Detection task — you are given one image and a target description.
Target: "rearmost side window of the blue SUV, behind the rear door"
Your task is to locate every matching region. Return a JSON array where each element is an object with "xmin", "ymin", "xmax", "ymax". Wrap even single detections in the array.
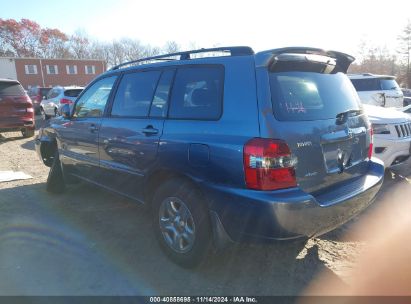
[{"xmin": 169, "ymin": 66, "xmax": 224, "ymax": 120}]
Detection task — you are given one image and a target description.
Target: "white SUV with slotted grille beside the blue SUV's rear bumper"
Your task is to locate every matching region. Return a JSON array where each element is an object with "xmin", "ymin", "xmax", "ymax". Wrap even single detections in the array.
[{"xmin": 364, "ymin": 105, "xmax": 411, "ymax": 167}]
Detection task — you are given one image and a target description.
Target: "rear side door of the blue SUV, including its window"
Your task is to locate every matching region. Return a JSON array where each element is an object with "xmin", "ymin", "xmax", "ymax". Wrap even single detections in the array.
[{"xmin": 99, "ymin": 69, "xmax": 174, "ymax": 199}]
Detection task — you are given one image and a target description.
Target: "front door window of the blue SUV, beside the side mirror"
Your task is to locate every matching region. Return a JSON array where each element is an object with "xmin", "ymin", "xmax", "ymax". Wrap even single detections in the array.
[{"xmin": 74, "ymin": 76, "xmax": 117, "ymax": 118}]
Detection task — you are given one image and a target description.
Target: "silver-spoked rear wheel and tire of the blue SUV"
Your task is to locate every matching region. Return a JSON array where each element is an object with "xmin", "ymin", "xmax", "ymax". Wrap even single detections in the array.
[{"xmin": 152, "ymin": 178, "xmax": 212, "ymax": 268}]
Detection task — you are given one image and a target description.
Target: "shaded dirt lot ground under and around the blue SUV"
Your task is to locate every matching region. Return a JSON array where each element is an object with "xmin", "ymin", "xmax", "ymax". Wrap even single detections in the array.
[{"xmin": 0, "ymin": 116, "xmax": 411, "ymax": 295}]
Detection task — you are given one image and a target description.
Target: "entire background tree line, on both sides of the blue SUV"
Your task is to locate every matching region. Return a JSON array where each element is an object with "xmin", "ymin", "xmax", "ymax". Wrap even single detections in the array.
[{"xmin": 0, "ymin": 18, "xmax": 411, "ymax": 88}]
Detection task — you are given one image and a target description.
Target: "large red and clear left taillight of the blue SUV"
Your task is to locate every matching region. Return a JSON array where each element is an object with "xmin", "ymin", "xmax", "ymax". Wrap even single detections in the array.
[{"xmin": 243, "ymin": 138, "xmax": 297, "ymax": 190}]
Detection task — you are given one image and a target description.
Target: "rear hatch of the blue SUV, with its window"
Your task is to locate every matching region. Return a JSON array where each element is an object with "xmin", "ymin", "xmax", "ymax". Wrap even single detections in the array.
[{"xmin": 268, "ymin": 50, "xmax": 370, "ymax": 194}]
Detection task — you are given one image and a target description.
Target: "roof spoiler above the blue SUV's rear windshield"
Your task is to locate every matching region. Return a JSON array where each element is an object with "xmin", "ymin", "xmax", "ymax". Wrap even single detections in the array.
[{"xmin": 256, "ymin": 47, "xmax": 355, "ymax": 73}]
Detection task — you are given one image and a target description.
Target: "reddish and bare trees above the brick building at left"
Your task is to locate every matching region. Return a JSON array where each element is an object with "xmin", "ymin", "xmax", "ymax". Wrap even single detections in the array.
[{"xmin": 0, "ymin": 18, "xmax": 180, "ymax": 67}]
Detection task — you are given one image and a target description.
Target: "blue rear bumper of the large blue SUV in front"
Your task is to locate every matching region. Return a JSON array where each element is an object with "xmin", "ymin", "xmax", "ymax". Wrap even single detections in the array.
[{"xmin": 205, "ymin": 161, "xmax": 384, "ymax": 242}]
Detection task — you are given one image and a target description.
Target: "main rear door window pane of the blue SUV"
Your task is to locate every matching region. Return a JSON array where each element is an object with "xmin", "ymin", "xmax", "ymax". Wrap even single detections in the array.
[{"xmin": 111, "ymin": 71, "xmax": 161, "ymax": 117}]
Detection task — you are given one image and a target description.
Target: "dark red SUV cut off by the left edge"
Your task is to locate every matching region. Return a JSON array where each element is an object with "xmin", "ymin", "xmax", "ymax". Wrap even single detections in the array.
[{"xmin": 0, "ymin": 79, "xmax": 35, "ymax": 137}]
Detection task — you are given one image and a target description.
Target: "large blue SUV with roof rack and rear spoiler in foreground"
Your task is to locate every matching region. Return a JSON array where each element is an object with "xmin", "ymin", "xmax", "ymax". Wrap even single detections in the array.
[{"xmin": 36, "ymin": 47, "xmax": 384, "ymax": 267}]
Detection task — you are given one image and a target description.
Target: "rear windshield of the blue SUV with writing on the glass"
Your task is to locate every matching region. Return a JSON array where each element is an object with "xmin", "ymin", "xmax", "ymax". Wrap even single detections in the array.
[{"xmin": 270, "ymin": 72, "xmax": 360, "ymax": 120}]
